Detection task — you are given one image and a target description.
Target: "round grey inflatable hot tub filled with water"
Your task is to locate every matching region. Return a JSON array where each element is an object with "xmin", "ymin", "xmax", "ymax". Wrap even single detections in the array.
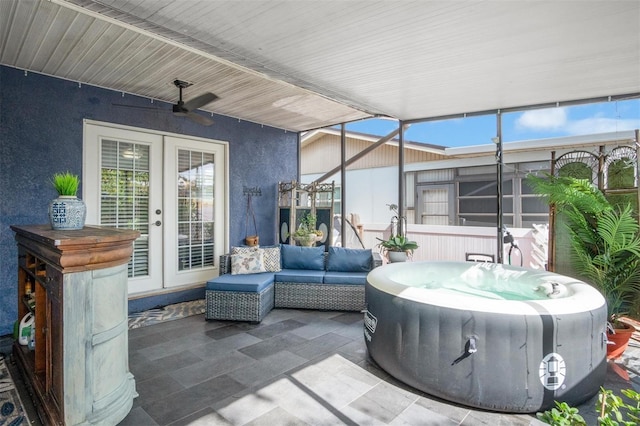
[{"xmin": 364, "ymin": 262, "xmax": 607, "ymax": 413}]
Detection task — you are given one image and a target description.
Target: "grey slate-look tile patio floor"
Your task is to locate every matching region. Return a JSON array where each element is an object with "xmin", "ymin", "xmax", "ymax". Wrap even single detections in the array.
[{"xmin": 116, "ymin": 309, "xmax": 640, "ymax": 426}]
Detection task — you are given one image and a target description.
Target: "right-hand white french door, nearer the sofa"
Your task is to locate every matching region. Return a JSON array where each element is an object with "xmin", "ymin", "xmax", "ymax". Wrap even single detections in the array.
[{"xmin": 164, "ymin": 136, "xmax": 228, "ymax": 287}]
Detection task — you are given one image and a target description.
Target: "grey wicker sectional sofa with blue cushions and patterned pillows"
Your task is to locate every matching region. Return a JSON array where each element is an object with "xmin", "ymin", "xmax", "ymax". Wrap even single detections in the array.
[{"xmin": 205, "ymin": 244, "xmax": 382, "ymax": 322}]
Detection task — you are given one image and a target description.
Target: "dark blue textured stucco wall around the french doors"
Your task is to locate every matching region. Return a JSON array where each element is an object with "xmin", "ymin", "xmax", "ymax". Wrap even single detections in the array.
[{"xmin": 0, "ymin": 66, "xmax": 298, "ymax": 335}]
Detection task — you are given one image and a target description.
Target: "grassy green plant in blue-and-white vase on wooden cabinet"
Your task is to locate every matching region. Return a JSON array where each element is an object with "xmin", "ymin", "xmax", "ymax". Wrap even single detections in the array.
[{"xmin": 49, "ymin": 171, "xmax": 87, "ymax": 230}]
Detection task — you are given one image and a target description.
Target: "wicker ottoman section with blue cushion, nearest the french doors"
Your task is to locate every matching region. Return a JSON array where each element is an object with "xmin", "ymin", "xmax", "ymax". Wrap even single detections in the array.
[{"xmin": 205, "ymin": 272, "xmax": 274, "ymax": 322}]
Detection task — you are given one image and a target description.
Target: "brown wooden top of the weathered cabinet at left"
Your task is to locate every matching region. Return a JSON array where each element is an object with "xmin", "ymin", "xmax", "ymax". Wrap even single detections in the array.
[{"xmin": 11, "ymin": 225, "xmax": 140, "ymax": 273}]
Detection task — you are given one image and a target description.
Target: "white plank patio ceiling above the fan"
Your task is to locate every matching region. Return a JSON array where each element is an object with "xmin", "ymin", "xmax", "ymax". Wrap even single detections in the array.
[{"xmin": 0, "ymin": 0, "xmax": 640, "ymax": 131}]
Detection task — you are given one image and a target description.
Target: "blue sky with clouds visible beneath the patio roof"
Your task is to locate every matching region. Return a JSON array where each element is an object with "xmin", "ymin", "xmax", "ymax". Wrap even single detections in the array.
[{"xmin": 347, "ymin": 99, "xmax": 640, "ymax": 147}]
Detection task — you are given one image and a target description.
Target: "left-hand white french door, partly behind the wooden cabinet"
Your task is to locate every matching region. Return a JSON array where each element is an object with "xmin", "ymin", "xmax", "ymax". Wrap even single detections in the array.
[{"xmin": 82, "ymin": 124, "xmax": 163, "ymax": 294}]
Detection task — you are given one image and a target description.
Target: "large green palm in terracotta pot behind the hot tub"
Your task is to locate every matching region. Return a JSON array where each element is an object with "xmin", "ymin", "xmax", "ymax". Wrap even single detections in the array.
[{"xmin": 529, "ymin": 176, "xmax": 640, "ymax": 358}]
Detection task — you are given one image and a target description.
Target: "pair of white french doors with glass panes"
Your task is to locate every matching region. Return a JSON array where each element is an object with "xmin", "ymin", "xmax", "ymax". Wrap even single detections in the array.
[{"xmin": 83, "ymin": 123, "xmax": 228, "ymax": 294}]
